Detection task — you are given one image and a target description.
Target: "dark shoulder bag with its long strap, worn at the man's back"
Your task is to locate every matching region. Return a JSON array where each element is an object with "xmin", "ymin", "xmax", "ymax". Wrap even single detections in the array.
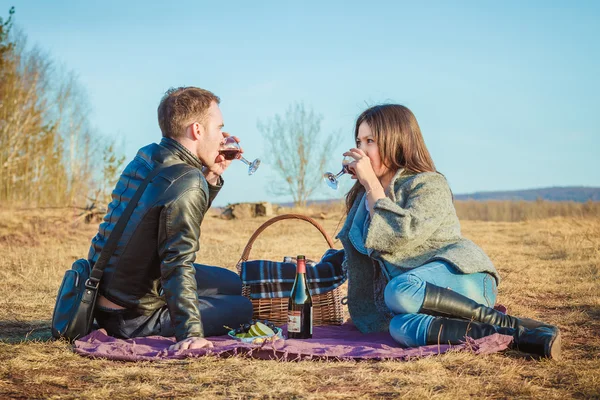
[{"xmin": 52, "ymin": 162, "xmax": 170, "ymax": 341}]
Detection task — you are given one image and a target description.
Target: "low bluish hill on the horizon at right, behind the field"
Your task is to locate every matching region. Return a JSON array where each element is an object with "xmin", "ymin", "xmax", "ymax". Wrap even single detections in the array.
[{"xmin": 454, "ymin": 186, "xmax": 600, "ymax": 203}]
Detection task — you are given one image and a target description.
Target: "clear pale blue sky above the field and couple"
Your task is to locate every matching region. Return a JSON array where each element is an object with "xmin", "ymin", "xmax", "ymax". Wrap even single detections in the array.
[{"xmin": 0, "ymin": 0, "xmax": 600, "ymax": 205}]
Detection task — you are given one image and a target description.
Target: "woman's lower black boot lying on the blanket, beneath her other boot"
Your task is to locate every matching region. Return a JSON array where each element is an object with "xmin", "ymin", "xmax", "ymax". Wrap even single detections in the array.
[{"xmin": 427, "ymin": 317, "xmax": 561, "ymax": 359}]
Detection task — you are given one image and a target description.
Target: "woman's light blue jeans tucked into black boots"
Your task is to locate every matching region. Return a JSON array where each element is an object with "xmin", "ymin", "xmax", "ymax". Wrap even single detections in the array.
[{"xmin": 384, "ymin": 261, "xmax": 498, "ymax": 347}]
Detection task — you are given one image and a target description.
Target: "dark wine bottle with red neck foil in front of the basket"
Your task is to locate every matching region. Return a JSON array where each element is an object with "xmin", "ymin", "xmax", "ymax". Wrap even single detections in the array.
[{"xmin": 288, "ymin": 256, "xmax": 312, "ymax": 339}]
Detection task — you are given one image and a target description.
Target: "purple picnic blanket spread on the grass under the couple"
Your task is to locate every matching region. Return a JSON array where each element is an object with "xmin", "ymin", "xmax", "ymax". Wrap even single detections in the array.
[{"xmin": 74, "ymin": 323, "xmax": 512, "ymax": 361}]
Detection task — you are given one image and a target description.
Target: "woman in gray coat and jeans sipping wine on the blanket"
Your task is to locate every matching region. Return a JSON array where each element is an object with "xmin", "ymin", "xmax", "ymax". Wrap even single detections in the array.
[{"xmin": 338, "ymin": 104, "xmax": 560, "ymax": 358}]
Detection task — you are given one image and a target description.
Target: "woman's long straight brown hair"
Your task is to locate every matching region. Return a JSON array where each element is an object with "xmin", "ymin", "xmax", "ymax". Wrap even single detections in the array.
[{"xmin": 346, "ymin": 104, "xmax": 437, "ymax": 213}]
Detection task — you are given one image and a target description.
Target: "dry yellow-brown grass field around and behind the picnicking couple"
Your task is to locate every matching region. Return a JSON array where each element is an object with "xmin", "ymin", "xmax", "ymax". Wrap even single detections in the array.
[{"xmin": 0, "ymin": 205, "xmax": 600, "ymax": 399}]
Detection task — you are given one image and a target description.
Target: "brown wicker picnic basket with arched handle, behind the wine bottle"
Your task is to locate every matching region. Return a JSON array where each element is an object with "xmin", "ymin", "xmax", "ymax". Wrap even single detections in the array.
[{"xmin": 238, "ymin": 214, "xmax": 344, "ymax": 325}]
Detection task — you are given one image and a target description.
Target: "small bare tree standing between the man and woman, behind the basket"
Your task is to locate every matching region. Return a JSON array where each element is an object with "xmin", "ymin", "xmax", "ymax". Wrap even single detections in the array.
[{"xmin": 257, "ymin": 103, "xmax": 340, "ymax": 206}]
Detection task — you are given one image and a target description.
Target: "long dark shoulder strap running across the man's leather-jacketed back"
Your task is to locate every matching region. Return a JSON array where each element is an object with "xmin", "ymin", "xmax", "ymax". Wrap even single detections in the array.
[{"xmin": 85, "ymin": 163, "xmax": 174, "ymax": 289}]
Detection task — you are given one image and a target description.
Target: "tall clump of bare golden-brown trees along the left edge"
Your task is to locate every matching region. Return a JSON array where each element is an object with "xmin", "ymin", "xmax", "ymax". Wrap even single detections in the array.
[{"xmin": 0, "ymin": 8, "xmax": 123, "ymax": 206}]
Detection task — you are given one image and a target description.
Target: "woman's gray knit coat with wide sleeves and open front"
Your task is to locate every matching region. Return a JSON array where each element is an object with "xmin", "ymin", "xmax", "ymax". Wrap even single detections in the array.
[{"xmin": 337, "ymin": 170, "xmax": 500, "ymax": 333}]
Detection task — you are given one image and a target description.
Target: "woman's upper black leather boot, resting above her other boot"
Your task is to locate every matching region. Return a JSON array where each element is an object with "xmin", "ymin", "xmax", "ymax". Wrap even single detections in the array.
[{"xmin": 419, "ymin": 283, "xmax": 558, "ymax": 334}]
